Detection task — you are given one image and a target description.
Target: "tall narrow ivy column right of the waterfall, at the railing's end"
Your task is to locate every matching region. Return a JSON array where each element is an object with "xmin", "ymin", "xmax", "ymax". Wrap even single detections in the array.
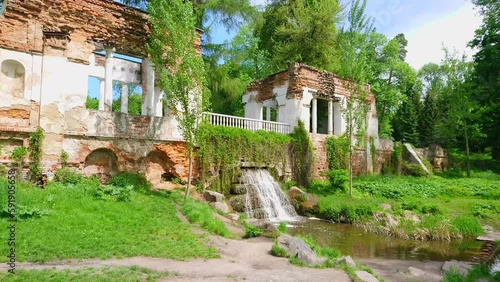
[{"xmin": 290, "ymin": 121, "xmax": 314, "ymax": 187}]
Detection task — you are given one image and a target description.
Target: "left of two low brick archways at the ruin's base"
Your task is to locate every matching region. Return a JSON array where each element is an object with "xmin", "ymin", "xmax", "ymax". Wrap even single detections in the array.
[{"xmin": 83, "ymin": 148, "xmax": 117, "ymax": 183}]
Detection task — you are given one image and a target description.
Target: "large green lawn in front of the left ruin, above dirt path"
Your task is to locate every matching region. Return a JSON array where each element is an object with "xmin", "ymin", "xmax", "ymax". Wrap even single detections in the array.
[{"xmin": 0, "ymin": 179, "xmax": 218, "ymax": 262}]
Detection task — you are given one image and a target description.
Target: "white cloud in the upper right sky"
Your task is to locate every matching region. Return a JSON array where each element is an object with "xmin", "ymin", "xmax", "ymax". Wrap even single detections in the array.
[{"xmin": 405, "ymin": 2, "xmax": 481, "ymax": 69}]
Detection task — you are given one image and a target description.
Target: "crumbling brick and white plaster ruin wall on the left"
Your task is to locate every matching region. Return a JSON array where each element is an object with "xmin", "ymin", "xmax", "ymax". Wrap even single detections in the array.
[{"xmin": 0, "ymin": 0, "xmax": 201, "ymax": 182}]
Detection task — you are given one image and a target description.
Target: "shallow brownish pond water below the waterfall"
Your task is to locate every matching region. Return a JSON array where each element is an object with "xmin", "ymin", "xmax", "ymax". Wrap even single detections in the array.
[{"xmin": 287, "ymin": 219, "xmax": 482, "ymax": 261}]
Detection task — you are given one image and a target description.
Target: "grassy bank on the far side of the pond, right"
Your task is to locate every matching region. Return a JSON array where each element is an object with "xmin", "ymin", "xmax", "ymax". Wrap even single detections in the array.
[{"xmin": 319, "ymin": 172, "xmax": 500, "ymax": 240}]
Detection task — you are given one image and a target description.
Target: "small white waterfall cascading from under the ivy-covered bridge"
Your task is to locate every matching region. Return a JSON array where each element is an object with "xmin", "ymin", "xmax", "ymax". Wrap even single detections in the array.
[{"xmin": 241, "ymin": 169, "xmax": 297, "ymax": 221}]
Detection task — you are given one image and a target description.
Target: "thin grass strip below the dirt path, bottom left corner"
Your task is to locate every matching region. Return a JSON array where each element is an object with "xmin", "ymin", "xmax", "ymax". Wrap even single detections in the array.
[{"xmin": 0, "ymin": 267, "xmax": 171, "ymax": 282}]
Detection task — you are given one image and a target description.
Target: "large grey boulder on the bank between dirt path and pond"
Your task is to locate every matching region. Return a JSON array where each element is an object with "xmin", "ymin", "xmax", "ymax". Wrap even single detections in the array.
[{"xmin": 277, "ymin": 234, "xmax": 326, "ymax": 266}]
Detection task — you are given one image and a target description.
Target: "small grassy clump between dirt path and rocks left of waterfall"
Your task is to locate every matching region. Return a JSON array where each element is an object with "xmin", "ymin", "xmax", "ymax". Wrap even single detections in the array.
[{"xmin": 181, "ymin": 200, "xmax": 234, "ymax": 238}]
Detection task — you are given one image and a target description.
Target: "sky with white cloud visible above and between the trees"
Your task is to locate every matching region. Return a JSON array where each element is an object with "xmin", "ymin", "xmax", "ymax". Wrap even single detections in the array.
[{"xmin": 211, "ymin": 0, "xmax": 481, "ymax": 69}]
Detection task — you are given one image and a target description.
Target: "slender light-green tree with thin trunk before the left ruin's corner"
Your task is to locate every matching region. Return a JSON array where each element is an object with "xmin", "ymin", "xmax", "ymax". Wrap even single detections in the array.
[{"xmin": 146, "ymin": 0, "xmax": 208, "ymax": 199}]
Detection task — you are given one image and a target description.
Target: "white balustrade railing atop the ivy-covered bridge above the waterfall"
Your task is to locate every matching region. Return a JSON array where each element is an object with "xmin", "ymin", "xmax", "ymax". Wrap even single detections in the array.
[{"xmin": 203, "ymin": 112, "xmax": 290, "ymax": 134}]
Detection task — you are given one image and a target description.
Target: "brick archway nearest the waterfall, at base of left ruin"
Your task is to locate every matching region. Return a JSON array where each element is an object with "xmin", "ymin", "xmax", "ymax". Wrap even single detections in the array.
[{"xmin": 140, "ymin": 150, "xmax": 176, "ymax": 186}]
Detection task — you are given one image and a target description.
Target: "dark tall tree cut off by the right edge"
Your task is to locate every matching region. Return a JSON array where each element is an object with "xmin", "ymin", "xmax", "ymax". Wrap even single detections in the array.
[{"xmin": 470, "ymin": 0, "xmax": 500, "ymax": 160}]
